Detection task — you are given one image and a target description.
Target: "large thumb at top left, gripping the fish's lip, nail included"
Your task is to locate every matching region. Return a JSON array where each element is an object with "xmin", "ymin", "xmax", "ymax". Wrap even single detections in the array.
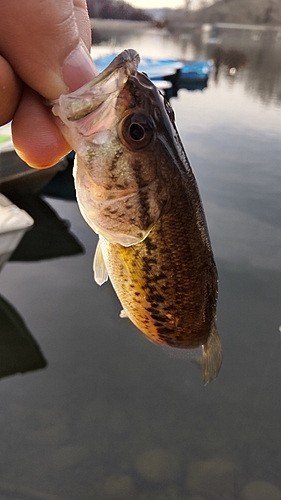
[{"xmin": 0, "ymin": 0, "xmax": 96, "ymax": 99}]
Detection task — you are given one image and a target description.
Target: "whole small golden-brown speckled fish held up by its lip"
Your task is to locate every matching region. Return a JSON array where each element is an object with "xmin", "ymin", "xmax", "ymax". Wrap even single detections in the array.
[{"xmin": 52, "ymin": 49, "xmax": 222, "ymax": 384}]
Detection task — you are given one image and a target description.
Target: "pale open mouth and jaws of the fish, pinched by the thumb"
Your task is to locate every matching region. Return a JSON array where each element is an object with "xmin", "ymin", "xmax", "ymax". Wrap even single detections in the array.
[{"xmin": 52, "ymin": 49, "xmax": 158, "ymax": 144}]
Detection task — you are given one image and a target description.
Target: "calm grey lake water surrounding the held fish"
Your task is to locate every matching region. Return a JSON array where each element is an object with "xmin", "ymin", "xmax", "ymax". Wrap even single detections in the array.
[{"xmin": 0, "ymin": 25, "xmax": 281, "ymax": 500}]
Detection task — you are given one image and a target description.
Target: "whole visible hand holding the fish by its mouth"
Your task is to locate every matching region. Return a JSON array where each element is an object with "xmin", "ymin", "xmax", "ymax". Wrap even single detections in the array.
[{"xmin": 0, "ymin": 0, "xmax": 97, "ymax": 168}]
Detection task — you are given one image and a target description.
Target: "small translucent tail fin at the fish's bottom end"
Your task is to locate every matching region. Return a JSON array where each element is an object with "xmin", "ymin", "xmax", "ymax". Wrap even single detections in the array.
[{"xmin": 202, "ymin": 321, "xmax": 222, "ymax": 385}]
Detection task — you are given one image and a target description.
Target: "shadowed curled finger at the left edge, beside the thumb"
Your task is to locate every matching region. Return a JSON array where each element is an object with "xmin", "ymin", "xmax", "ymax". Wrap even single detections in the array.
[{"xmin": 0, "ymin": 56, "xmax": 22, "ymax": 126}]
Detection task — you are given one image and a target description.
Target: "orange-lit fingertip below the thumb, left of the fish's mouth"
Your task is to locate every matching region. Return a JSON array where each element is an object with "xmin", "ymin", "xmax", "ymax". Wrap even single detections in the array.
[{"xmin": 12, "ymin": 87, "xmax": 70, "ymax": 168}]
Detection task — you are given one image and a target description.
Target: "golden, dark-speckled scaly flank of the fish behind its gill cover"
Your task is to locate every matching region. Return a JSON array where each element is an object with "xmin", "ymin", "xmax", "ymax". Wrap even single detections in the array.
[{"xmin": 103, "ymin": 188, "xmax": 213, "ymax": 347}]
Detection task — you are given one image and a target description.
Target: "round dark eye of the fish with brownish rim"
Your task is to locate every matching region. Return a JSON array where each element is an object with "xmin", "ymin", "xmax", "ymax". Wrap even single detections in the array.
[{"xmin": 118, "ymin": 112, "xmax": 155, "ymax": 150}]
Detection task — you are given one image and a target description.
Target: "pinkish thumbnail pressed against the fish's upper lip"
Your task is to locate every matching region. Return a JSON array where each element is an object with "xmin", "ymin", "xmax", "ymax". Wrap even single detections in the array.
[{"xmin": 62, "ymin": 42, "xmax": 98, "ymax": 92}]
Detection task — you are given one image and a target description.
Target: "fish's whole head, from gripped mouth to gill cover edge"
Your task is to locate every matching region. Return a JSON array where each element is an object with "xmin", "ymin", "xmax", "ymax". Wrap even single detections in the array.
[{"xmin": 53, "ymin": 49, "xmax": 179, "ymax": 246}]
